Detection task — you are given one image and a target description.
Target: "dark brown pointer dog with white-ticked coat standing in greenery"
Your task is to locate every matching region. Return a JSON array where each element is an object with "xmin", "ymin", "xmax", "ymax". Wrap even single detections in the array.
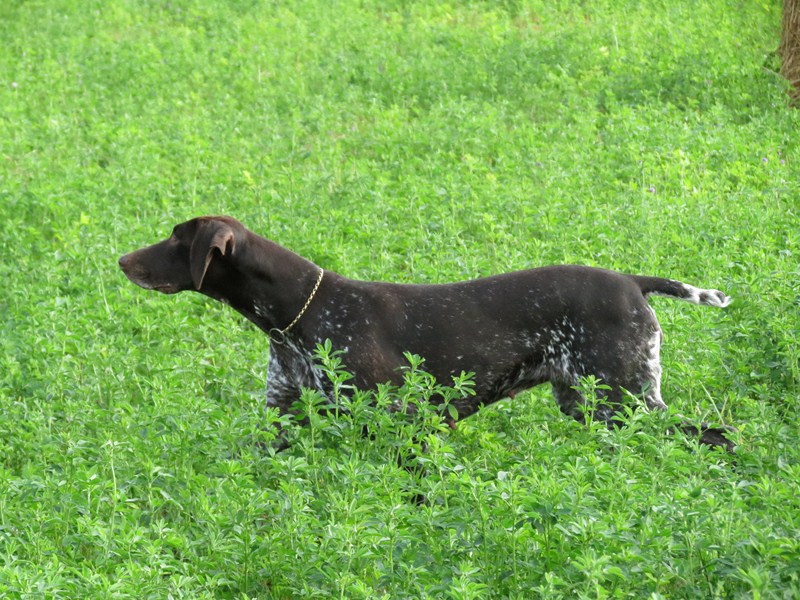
[{"xmin": 119, "ymin": 216, "xmax": 733, "ymax": 451}]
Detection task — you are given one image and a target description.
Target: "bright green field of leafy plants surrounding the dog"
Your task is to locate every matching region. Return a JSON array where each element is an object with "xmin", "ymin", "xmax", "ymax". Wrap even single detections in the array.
[{"xmin": 0, "ymin": 0, "xmax": 800, "ymax": 599}]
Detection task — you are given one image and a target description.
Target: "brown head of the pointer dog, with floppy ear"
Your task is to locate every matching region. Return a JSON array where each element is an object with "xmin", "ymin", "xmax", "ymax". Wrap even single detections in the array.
[{"xmin": 119, "ymin": 217, "xmax": 243, "ymax": 294}]
